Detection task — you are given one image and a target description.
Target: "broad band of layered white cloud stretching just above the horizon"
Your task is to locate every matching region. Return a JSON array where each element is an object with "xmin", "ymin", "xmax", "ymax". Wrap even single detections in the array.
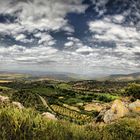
[{"xmin": 0, "ymin": 41, "xmax": 140, "ymax": 74}]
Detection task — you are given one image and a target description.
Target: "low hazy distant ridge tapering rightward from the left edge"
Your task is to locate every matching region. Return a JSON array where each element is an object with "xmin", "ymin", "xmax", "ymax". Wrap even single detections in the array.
[{"xmin": 0, "ymin": 71, "xmax": 88, "ymax": 81}]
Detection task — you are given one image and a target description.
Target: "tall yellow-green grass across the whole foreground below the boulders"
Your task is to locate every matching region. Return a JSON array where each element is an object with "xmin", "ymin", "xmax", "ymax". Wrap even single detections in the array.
[{"xmin": 0, "ymin": 106, "xmax": 140, "ymax": 140}]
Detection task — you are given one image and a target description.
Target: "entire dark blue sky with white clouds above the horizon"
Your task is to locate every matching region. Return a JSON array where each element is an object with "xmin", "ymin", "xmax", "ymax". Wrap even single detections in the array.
[{"xmin": 0, "ymin": 0, "xmax": 140, "ymax": 75}]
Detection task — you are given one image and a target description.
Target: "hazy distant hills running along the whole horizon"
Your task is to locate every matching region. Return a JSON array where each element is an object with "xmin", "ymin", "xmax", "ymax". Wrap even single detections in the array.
[{"xmin": 0, "ymin": 71, "xmax": 140, "ymax": 81}]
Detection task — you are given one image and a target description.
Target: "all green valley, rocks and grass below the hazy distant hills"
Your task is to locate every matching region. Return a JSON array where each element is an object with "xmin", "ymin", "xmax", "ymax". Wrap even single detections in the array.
[{"xmin": 0, "ymin": 80, "xmax": 140, "ymax": 140}]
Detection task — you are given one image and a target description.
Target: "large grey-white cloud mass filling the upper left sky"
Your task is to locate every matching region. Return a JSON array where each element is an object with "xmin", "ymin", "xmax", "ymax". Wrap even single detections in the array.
[{"xmin": 0, "ymin": 0, "xmax": 87, "ymax": 45}]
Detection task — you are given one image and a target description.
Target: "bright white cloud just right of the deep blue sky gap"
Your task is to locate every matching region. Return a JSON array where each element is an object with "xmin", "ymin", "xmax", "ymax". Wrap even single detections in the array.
[{"xmin": 89, "ymin": 20, "xmax": 140, "ymax": 43}]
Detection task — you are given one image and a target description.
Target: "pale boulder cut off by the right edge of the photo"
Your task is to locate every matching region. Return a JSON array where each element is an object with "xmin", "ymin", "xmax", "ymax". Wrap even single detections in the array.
[{"xmin": 128, "ymin": 100, "xmax": 140, "ymax": 113}]
